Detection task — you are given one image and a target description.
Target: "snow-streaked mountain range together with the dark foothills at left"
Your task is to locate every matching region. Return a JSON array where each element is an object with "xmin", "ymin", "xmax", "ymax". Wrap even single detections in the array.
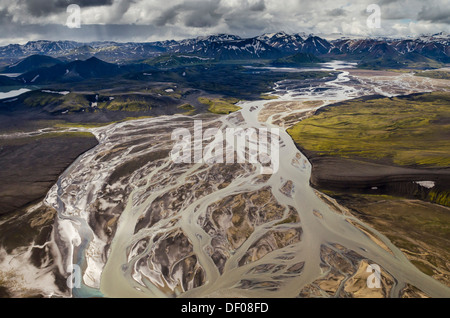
[{"xmin": 0, "ymin": 32, "xmax": 450, "ymax": 86}]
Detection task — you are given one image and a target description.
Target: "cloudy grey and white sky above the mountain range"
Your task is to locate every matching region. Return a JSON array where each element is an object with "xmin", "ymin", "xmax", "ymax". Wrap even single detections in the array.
[{"xmin": 0, "ymin": 0, "xmax": 450, "ymax": 45}]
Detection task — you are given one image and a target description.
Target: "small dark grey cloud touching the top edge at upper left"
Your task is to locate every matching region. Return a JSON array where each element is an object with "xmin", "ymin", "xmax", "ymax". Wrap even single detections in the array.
[{"xmin": 21, "ymin": 0, "xmax": 113, "ymax": 17}]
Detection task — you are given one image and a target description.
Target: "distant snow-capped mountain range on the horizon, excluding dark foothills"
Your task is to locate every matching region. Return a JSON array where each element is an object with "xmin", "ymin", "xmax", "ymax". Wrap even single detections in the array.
[{"xmin": 0, "ymin": 32, "xmax": 450, "ymax": 65}]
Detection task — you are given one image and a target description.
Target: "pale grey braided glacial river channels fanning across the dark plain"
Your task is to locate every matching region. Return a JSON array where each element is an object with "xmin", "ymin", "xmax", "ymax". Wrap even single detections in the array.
[{"xmin": 46, "ymin": 62, "xmax": 450, "ymax": 298}]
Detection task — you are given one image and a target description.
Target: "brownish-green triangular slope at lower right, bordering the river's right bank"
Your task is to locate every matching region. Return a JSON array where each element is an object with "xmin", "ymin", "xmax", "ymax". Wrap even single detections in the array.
[{"xmin": 328, "ymin": 192, "xmax": 450, "ymax": 285}]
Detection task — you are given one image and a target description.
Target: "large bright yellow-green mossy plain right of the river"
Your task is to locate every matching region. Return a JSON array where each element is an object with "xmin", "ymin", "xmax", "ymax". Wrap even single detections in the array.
[{"xmin": 288, "ymin": 92, "xmax": 450, "ymax": 167}]
